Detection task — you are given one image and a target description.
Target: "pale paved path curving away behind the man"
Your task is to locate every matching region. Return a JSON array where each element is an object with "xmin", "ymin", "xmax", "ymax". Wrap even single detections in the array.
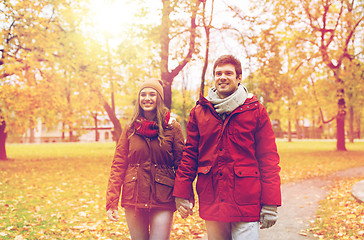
[{"xmin": 202, "ymin": 166, "xmax": 364, "ymax": 240}]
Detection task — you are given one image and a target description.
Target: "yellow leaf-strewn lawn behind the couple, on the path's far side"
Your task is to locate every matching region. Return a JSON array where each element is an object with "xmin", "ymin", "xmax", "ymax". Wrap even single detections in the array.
[{"xmin": 0, "ymin": 142, "xmax": 364, "ymax": 239}]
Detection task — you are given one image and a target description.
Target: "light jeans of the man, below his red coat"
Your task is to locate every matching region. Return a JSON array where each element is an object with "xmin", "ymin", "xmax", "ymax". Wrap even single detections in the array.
[{"xmin": 205, "ymin": 221, "xmax": 259, "ymax": 240}]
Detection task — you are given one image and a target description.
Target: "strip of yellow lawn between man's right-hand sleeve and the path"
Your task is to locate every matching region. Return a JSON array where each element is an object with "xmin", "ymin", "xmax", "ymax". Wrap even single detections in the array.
[{"xmin": 277, "ymin": 141, "xmax": 364, "ymax": 183}]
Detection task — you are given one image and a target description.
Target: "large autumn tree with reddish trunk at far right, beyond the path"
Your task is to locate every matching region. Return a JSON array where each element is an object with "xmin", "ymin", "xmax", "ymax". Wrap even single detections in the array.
[{"xmin": 229, "ymin": 0, "xmax": 363, "ymax": 150}]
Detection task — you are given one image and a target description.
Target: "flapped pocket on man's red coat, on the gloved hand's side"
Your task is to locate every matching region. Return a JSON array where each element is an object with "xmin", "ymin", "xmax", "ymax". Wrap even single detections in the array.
[{"xmin": 234, "ymin": 166, "xmax": 261, "ymax": 205}]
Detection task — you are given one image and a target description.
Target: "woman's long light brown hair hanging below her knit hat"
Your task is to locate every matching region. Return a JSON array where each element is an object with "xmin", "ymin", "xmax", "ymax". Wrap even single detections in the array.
[{"xmin": 129, "ymin": 93, "xmax": 168, "ymax": 145}]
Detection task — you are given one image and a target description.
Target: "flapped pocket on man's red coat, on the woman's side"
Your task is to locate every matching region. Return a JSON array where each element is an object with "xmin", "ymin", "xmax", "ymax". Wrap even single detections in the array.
[{"xmin": 196, "ymin": 166, "xmax": 215, "ymax": 204}]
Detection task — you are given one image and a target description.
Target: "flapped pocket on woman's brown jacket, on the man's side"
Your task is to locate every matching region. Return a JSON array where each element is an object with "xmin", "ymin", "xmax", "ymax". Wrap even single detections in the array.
[{"xmin": 154, "ymin": 172, "xmax": 174, "ymax": 203}]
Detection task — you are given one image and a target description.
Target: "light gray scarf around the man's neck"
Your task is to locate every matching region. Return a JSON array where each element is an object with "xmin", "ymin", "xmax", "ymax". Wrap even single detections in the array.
[{"xmin": 206, "ymin": 84, "xmax": 252, "ymax": 116}]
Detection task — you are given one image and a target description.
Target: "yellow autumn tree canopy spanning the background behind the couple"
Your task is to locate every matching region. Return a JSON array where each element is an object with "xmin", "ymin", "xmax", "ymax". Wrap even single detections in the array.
[{"xmin": 0, "ymin": 0, "xmax": 364, "ymax": 156}]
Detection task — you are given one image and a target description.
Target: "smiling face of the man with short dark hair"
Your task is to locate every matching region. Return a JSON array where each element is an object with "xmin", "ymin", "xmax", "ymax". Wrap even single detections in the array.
[{"xmin": 214, "ymin": 63, "xmax": 241, "ymax": 98}]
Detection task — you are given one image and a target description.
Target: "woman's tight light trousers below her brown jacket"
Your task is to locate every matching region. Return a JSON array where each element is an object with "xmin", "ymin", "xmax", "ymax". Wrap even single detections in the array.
[{"xmin": 125, "ymin": 207, "xmax": 173, "ymax": 240}]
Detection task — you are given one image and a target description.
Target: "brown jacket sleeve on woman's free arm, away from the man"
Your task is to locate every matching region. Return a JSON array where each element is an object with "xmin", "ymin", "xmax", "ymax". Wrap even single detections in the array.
[{"xmin": 106, "ymin": 127, "xmax": 129, "ymax": 211}]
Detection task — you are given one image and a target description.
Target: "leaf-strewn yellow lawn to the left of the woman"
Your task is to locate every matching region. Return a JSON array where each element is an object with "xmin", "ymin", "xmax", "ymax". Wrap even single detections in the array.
[{"xmin": 0, "ymin": 143, "xmax": 127, "ymax": 239}]
